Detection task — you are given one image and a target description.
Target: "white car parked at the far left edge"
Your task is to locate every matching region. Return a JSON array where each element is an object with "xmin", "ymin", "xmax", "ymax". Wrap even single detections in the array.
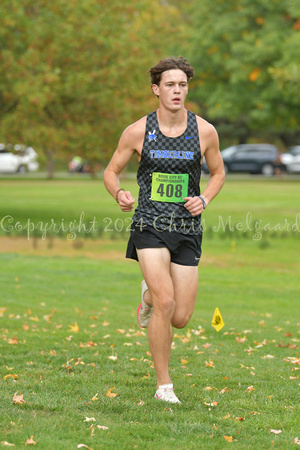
[{"xmin": 0, "ymin": 144, "xmax": 39, "ymax": 173}]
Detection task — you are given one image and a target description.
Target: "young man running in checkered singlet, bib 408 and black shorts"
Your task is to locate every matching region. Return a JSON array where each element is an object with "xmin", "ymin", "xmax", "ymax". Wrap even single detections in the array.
[{"xmin": 104, "ymin": 57, "xmax": 225, "ymax": 403}]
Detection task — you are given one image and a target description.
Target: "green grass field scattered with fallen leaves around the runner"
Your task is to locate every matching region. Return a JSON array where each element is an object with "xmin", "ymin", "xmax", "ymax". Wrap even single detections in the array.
[{"xmin": 0, "ymin": 177, "xmax": 300, "ymax": 450}]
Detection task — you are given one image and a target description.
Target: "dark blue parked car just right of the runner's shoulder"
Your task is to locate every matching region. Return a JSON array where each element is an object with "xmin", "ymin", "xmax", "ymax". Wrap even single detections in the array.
[{"xmin": 221, "ymin": 144, "xmax": 285, "ymax": 176}]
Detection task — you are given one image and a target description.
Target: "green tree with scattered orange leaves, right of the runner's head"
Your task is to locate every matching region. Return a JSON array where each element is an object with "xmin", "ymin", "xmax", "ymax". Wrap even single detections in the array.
[{"xmin": 182, "ymin": 0, "xmax": 300, "ymax": 145}]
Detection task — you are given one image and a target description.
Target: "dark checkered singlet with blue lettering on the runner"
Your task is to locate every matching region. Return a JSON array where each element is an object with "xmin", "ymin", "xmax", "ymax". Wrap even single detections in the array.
[{"xmin": 133, "ymin": 111, "xmax": 201, "ymax": 235}]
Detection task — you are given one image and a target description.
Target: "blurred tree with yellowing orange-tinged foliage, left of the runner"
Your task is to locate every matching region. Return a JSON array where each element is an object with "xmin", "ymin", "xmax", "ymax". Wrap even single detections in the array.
[{"xmin": 0, "ymin": 0, "xmax": 180, "ymax": 176}]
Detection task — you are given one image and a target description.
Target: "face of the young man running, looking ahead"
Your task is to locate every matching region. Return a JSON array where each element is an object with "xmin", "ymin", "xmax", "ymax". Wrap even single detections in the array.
[{"xmin": 152, "ymin": 69, "xmax": 188, "ymax": 110}]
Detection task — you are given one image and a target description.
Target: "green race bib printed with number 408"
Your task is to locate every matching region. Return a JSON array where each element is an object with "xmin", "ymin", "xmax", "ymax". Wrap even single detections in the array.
[{"xmin": 151, "ymin": 172, "xmax": 189, "ymax": 203}]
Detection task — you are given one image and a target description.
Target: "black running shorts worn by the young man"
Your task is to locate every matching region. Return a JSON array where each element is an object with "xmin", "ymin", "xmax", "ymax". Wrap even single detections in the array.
[{"xmin": 126, "ymin": 223, "xmax": 202, "ymax": 266}]
